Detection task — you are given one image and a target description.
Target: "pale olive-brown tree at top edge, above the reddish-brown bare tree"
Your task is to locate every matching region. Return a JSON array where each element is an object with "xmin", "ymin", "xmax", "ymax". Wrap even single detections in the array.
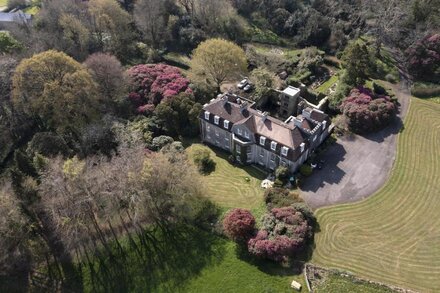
[{"xmin": 88, "ymin": 0, "xmax": 133, "ymax": 59}]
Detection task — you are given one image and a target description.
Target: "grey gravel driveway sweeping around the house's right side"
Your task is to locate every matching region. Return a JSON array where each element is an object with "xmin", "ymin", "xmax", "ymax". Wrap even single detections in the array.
[{"xmin": 301, "ymin": 81, "xmax": 410, "ymax": 209}]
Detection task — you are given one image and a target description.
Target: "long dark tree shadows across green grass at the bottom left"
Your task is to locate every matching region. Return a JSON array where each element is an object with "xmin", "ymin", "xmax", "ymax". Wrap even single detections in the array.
[{"xmin": 83, "ymin": 226, "xmax": 226, "ymax": 292}]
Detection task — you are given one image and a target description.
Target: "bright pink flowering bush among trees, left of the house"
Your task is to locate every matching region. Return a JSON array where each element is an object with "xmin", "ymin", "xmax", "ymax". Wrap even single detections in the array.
[{"xmin": 127, "ymin": 64, "xmax": 192, "ymax": 113}]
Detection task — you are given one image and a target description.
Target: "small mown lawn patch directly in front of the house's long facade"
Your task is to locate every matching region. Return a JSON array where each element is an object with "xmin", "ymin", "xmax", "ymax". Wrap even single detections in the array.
[{"xmin": 188, "ymin": 143, "xmax": 266, "ymax": 209}]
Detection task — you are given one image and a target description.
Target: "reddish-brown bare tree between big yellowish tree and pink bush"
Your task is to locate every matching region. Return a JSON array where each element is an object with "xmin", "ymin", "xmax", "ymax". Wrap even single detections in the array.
[{"xmin": 84, "ymin": 53, "xmax": 126, "ymax": 102}]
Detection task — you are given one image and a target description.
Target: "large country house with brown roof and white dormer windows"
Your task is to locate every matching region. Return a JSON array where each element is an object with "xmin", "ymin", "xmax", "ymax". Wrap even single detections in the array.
[{"xmin": 199, "ymin": 94, "xmax": 331, "ymax": 172}]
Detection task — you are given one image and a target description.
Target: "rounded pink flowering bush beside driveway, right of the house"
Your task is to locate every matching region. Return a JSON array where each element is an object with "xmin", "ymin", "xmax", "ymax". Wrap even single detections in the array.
[{"xmin": 341, "ymin": 87, "xmax": 397, "ymax": 133}]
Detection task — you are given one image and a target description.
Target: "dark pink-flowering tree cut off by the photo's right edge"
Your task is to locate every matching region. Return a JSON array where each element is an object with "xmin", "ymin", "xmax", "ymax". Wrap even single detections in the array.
[{"xmin": 406, "ymin": 34, "xmax": 440, "ymax": 82}]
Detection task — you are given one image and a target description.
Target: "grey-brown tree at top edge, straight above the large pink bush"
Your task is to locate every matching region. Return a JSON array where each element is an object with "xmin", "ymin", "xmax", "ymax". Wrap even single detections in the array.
[{"xmin": 134, "ymin": 0, "xmax": 169, "ymax": 48}]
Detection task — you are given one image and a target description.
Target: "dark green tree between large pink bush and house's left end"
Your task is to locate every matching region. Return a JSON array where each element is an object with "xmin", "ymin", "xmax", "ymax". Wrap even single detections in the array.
[{"xmin": 154, "ymin": 93, "xmax": 202, "ymax": 136}]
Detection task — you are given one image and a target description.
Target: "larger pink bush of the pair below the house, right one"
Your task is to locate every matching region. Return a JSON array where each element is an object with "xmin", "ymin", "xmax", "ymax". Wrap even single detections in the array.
[{"xmin": 248, "ymin": 207, "xmax": 313, "ymax": 262}]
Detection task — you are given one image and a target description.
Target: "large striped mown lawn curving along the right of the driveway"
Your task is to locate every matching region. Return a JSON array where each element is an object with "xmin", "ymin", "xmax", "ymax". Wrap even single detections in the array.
[{"xmin": 312, "ymin": 98, "xmax": 440, "ymax": 292}]
